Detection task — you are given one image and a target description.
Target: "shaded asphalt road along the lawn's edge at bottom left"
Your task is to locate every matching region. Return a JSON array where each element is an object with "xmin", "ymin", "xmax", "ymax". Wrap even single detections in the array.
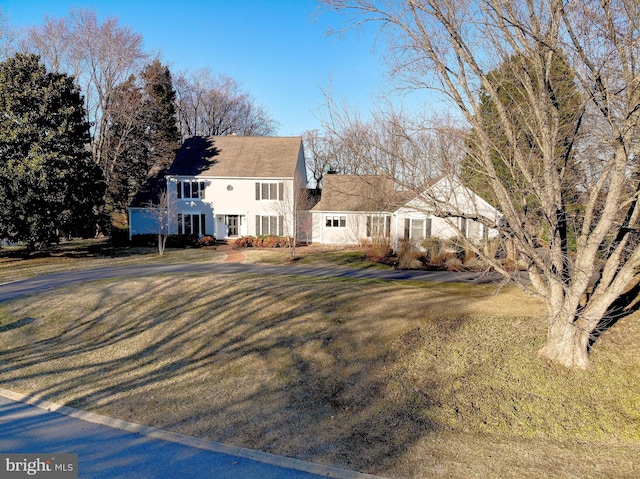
[{"xmin": 0, "ymin": 391, "xmax": 374, "ymax": 479}]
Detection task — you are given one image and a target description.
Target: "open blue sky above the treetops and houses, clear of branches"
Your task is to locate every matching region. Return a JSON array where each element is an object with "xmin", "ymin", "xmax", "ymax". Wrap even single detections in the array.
[{"xmin": 0, "ymin": 0, "xmax": 386, "ymax": 136}]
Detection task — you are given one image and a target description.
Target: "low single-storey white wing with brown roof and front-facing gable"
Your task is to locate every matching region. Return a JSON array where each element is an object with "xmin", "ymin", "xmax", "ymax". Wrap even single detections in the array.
[{"xmin": 311, "ymin": 175, "xmax": 500, "ymax": 248}]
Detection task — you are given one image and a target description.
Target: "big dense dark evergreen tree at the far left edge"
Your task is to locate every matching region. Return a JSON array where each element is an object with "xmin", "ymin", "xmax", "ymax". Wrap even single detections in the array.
[{"xmin": 0, "ymin": 54, "xmax": 105, "ymax": 248}]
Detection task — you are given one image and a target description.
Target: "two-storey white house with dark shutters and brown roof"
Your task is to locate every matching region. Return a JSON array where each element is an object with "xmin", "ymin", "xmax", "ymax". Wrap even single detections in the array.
[{"xmin": 129, "ymin": 136, "xmax": 307, "ymax": 239}]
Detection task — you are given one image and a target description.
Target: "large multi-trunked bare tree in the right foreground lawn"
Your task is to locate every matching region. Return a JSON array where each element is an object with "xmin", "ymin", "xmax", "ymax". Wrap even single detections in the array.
[{"xmin": 325, "ymin": 0, "xmax": 640, "ymax": 368}]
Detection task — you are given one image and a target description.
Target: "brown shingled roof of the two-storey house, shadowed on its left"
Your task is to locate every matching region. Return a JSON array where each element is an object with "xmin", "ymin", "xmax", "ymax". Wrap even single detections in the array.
[{"xmin": 167, "ymin": 136, "xmax": 302, "ymax": 178}]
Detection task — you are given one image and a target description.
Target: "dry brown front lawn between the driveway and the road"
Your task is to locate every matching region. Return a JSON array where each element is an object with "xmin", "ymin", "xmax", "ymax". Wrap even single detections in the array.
[{"xmin": 0, "ymin": 276, "xmax": 640, "ymax": 478}]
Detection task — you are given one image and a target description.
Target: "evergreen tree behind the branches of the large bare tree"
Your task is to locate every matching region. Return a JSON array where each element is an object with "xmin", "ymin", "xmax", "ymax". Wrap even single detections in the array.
[{"xmin": 462, "ymin": 55, "xmax": 584, "ymax": 248}]
